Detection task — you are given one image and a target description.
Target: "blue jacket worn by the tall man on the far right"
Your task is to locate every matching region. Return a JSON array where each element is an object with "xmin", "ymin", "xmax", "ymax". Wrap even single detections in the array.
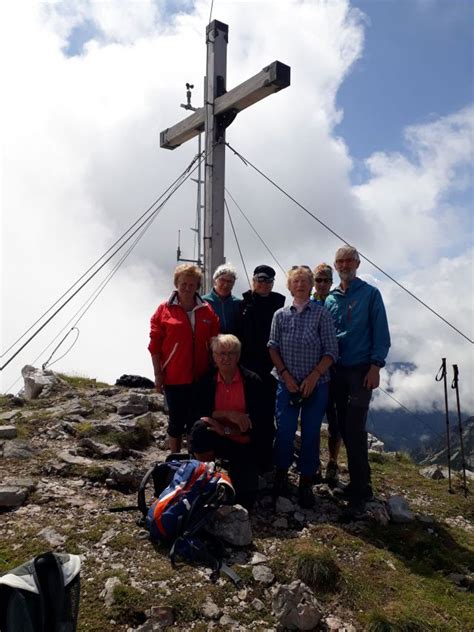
[{"xmin": 324, "ymin": 277, "xmax": 390, "ymax": 366}]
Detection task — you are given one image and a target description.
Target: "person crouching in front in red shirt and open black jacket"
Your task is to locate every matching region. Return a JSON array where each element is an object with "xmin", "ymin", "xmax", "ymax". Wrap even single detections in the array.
[{"xmin": 191, "ymin": 334, "xmax": 262, "ymax": 508}]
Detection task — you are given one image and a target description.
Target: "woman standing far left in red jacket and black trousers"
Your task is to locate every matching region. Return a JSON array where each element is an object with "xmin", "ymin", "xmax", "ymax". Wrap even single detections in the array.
[{"xmin": 148, "ymin": 263, "xmax": 219, "ymax": 452}]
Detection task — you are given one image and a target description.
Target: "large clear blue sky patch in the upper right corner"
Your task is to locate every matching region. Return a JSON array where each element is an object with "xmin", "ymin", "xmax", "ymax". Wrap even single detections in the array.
[{"xmin": 336, "ymin": 0, "xmax": 474, "ymax": 160}]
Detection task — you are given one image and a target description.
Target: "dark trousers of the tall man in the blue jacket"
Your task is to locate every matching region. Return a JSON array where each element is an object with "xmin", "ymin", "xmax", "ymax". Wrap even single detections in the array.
[{"xmin": 333, "ymin": 364, "xmax": 372, "ymax": 500}]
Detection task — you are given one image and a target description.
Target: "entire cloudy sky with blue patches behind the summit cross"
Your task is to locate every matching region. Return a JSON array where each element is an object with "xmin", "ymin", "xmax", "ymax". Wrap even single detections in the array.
[{"xmin": 0, "ymin": 0, "xmax": 474, "ymax": 422}]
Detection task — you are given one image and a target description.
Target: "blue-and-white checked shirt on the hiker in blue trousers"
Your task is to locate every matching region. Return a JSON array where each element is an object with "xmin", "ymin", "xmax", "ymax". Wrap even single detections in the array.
[{"xmin": 268, "ymin": 301, "xmax": 338, "ymax": 384}]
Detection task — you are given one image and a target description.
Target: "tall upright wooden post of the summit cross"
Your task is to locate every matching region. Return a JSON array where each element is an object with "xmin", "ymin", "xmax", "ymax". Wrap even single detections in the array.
[{"xmin": 204, "ymin": 20, "xmax": 229, "ymax": 292}]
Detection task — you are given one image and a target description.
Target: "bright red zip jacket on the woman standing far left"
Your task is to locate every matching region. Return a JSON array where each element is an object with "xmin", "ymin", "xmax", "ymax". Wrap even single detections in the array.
[{"xmin": 148, "ymin": 292, "xmax": 219, "ymax": 384}]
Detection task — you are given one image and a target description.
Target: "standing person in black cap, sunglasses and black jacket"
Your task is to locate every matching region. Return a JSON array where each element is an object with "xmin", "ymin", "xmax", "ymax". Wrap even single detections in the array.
[{"xmin": 239, "ymin": 265, "xmax": 285, "ymax": 472}]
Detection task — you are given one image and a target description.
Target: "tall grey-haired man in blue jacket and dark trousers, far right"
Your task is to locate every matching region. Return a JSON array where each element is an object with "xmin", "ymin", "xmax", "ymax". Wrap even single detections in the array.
[{"xmin": 324, "ymin": 246, "xmax": 390, "ymax": 514}]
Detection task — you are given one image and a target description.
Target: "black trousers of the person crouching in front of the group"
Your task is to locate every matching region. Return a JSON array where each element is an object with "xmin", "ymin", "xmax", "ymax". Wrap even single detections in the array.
[{"xmin": 191, "ymin": 420, "xmax": 258, "ymax": 507}]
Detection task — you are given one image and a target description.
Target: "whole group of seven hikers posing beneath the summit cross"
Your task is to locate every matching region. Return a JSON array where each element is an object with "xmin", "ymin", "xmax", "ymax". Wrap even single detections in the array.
[{"xmin": 148, "ymin": 246, "xmax": 390, "ymax": 515}]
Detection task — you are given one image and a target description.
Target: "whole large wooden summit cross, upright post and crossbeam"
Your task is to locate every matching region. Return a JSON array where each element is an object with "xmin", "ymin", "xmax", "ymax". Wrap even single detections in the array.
[{"xmin": 160, "ymin": 20, "xmax": 290, "ymax": 292}]
